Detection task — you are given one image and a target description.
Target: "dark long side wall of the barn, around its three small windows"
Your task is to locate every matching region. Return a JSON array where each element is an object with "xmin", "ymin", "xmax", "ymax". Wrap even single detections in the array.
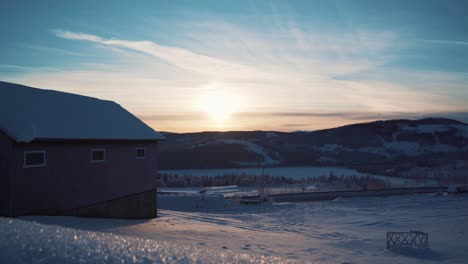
[{"xmin": 9, "ymin": 141, "xmax": 157, "ymax": 215}]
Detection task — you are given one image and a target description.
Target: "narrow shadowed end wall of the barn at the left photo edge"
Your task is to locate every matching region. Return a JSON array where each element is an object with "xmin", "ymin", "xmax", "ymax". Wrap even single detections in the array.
[{"xmin": 0, "ymin": 131, "xmax": 13, "ymax": 216}]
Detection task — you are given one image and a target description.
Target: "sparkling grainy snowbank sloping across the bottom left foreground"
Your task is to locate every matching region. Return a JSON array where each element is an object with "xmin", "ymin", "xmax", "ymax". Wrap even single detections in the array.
[{"xmin": 0, "ymin": 217, "xmax": 293, "ymax": 264}]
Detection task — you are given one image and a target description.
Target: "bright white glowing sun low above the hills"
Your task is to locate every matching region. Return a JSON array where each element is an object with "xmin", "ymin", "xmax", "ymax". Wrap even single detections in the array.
[{"xmin": 199, "ymin": 92, "xmax": 239, "ymax": 122}]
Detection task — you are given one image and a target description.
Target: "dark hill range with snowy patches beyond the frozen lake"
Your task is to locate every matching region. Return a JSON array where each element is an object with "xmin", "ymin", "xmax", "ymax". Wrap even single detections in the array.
[{"xmin": 160, "ymin": 118, "xmax": 468, "ymax": 174}]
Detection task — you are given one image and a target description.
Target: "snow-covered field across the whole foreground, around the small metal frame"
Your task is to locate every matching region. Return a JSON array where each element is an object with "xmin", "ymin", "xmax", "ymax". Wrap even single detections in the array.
[{"xmin": 5, "ymin": 194, "xmax": 468, "ymax": 263}]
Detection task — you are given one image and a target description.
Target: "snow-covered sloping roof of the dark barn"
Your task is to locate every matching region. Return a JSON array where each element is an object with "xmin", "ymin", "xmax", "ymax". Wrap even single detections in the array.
[{"xmin": 0, "ymin": 82, "xmax": 164, "ymax": 142}]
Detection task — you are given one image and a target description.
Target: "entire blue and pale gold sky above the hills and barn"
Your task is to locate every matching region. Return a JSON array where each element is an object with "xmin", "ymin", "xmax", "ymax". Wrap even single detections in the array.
[{"xmin": 0, "ymin": 0, "xmax": 468, "ymax": 132}]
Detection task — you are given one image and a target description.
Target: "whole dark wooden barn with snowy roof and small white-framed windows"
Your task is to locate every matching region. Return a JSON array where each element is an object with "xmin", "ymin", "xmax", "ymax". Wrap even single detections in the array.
[{"xmin": 0, "ymin": 82, "xmax": 164, "ymax": 218}]
